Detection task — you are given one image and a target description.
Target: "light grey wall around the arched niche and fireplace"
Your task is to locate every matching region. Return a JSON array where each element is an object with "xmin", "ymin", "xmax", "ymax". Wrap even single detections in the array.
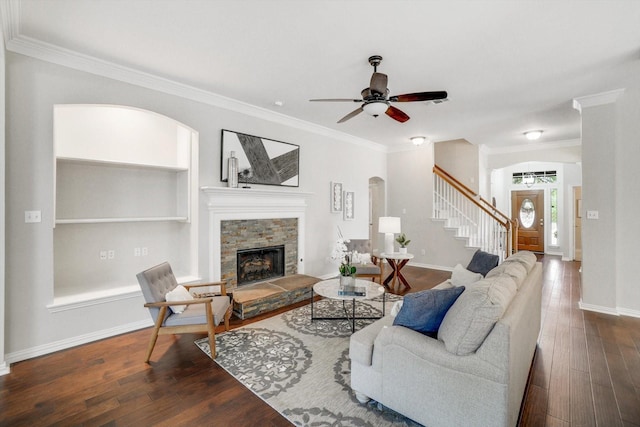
[{"xmin": 0, "ymin": 54, "xmax": 387, "ymax": 361}]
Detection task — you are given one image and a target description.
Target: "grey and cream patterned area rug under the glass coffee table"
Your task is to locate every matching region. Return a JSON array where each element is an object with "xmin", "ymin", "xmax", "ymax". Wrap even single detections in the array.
[{"xmin": 195, "ymin": 294, "xmax": 420, "ymax": 427}]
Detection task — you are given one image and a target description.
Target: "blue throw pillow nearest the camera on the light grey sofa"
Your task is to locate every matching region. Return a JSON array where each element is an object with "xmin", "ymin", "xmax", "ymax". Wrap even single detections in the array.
[{"xmin": 393, "ymin": 286, "xmax": 464, "ymax": 335}]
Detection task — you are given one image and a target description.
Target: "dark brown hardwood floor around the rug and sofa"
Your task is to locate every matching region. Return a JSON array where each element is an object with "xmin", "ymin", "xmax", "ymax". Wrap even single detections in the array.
[{"xmin": 0, "ymin": 256, "xmax": 640, "ymax": 427}]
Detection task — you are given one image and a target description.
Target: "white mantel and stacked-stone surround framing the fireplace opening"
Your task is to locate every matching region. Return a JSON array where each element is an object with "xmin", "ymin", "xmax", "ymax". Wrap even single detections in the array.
[{"xmin": 201, "ymin": 187, "xmax": 311, "ymax": 289}]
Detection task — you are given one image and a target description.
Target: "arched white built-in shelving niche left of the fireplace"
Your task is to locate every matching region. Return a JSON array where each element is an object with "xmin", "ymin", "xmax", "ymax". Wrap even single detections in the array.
[{"xmin": 50, "ymin": 105, "xmax": 198, "ymax": 311}]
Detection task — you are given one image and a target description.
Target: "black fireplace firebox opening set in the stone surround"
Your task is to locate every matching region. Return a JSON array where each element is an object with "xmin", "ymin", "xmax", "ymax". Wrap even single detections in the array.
[{"xmin": 236, "ymin": 245, "xmax": 284, "ymax": 286}]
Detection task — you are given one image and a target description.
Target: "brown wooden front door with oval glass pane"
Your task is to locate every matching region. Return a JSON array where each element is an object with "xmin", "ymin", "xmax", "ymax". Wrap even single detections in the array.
[{"xmin": 511, "ymin": 190, "xmax": 544, "ymax": 252}]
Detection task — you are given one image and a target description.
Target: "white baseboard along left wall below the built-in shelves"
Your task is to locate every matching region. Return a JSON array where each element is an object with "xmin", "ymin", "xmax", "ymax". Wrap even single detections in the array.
[{"xmin": 5, "ymin": 319, "xmax": 153, "ymax": 366}]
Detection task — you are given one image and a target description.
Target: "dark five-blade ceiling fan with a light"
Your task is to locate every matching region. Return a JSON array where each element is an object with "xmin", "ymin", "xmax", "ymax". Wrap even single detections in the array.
[{"xmin": 309, "ymin": 55, "xmax": 447, "ymax": 123}]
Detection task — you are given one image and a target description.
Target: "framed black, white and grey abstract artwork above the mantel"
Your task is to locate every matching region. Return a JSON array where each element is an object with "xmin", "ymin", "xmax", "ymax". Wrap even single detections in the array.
[{"xmin": 220, "ymin": 129, "xmax": 300, "ymax": 187}]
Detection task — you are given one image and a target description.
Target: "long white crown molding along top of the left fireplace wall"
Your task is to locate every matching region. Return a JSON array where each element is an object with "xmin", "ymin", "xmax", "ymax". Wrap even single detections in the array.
[{"xmin": 0, "ymin": 0, "xmax": 388, "ymax": 153}]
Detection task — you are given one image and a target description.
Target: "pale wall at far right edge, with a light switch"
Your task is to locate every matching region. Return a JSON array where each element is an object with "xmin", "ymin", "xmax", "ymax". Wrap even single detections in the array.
[{"xmin": 576, "ymin": 84, "xmax": 640, "ymax": 317}]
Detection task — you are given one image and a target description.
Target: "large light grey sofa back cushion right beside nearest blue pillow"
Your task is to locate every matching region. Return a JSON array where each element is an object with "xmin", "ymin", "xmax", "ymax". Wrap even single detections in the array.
[{"xmin": 438, "ymin": 275, "xmax": 516, "ymax": 356}]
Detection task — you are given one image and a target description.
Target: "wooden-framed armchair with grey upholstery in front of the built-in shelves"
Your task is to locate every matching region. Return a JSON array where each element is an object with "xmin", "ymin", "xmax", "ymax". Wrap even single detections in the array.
[{"xmin": 136, "ymin": 262, "xmax": 233, "ymax": 363}]
